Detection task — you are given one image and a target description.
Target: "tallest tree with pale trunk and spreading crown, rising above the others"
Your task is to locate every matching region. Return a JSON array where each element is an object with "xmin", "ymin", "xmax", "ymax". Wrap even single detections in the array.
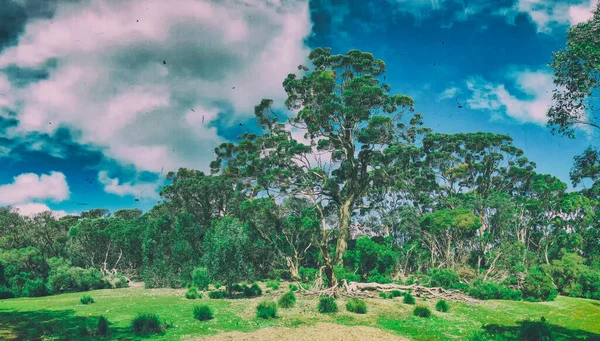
[{"xmin": 212, "ymin": 48, "xmax": 427, "ymax": 285}]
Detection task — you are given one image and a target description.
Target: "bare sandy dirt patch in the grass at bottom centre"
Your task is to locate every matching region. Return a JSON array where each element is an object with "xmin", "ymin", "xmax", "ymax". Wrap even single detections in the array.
[{"xmin": 189, "ymin": 323, "xmax": 408, "ymax": 341}]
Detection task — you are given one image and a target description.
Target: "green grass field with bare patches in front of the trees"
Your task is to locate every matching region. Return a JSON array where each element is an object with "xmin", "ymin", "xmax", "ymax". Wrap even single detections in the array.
[{"xmin": 0, "ymin": 285, "xmax": 600, "ymax": 341}]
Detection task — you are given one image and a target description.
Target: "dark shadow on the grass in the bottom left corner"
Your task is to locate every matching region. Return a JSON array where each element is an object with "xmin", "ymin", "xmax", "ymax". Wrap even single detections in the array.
[{"xmin": 0, "ymin": 310, "xmax": 162, "ymax": 340}]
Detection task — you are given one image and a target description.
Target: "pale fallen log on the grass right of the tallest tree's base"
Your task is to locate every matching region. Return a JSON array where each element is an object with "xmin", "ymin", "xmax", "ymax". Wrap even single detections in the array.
[{"xmin": 344, "ymin": 282, "xmax": 479, "ymax": 303}]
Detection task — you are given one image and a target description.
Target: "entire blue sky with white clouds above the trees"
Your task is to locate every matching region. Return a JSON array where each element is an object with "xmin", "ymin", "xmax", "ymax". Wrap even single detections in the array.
[{"xmin": 0, "ymin": 0, "xmax": 598, "ymax": 216}]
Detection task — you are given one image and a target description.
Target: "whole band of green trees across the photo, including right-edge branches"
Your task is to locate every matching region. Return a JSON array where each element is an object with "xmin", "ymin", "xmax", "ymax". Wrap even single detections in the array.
[{"xmin": 0, "ymin": 4, "xmax": 600, "ymax": 300}]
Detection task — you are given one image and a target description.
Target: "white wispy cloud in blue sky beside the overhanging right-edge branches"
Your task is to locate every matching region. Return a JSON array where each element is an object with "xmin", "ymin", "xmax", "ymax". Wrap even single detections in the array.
[{"xmin": 466, "ymin": 69, "xmax": 554, "ymax": 125}]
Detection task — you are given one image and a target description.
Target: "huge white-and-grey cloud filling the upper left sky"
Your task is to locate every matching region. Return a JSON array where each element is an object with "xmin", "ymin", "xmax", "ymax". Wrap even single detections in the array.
[{"xmin": 0, "ymin": 0, "xmax": 311, "ymax": 172}]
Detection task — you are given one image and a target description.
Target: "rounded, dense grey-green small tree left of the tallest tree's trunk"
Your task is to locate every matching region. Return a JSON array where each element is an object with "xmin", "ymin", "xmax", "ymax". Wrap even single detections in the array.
[{"xmin": 203, "ymin": 216, "xmax": 253, "ymax": 293}]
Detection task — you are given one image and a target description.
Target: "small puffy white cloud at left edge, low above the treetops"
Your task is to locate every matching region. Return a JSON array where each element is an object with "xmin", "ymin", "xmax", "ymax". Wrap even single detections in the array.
[{"xmin": 0, "ymin": 172, "xmax": 70, "ymax": 206}]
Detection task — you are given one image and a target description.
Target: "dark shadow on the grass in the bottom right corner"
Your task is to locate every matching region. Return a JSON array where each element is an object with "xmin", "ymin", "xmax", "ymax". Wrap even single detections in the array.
[{"xmin": 483, "ymin": 321, "xmax": 600, "ymax": 341}]
